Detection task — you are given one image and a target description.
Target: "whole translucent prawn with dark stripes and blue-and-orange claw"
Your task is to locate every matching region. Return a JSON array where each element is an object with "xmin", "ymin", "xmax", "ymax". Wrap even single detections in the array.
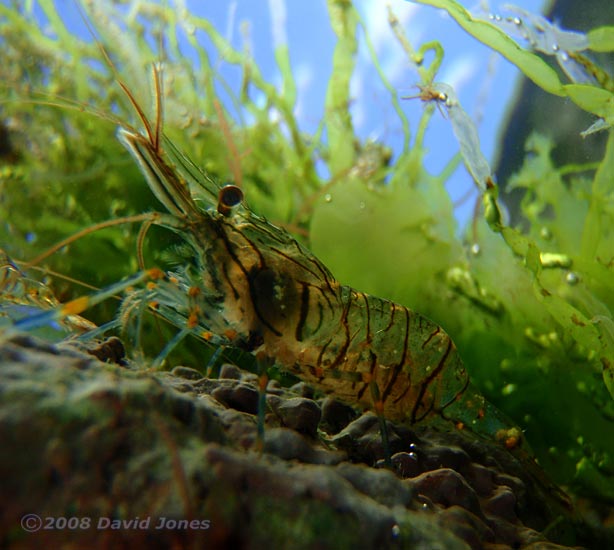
[{"xmin": 15, "ymin": 68, "xmax": 522, "ymax": 448}]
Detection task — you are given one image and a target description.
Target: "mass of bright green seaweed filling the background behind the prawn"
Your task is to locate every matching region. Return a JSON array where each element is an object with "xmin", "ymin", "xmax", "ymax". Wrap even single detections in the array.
[{"xmin": 0, "ymin": 0, "xmax": 614, "ymax": 501}]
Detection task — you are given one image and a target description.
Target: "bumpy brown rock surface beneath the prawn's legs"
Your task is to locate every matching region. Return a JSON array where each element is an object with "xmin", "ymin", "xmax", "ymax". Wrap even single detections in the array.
[{"xmin": 0, "ymin": 336, "xmax": 604, "ymax": 549}]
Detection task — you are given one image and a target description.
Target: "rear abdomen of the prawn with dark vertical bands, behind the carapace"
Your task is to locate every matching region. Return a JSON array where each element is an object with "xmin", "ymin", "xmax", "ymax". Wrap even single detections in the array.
[{"xmin": 260, "ymin": 287, "xmax": 469, "ymax": 423}]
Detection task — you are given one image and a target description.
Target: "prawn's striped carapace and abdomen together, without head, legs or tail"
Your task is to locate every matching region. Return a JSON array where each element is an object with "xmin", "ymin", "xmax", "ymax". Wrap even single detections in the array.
[{"xmin": 202, "ymin": 218, "xmax": 468, "ymax": 423}]
